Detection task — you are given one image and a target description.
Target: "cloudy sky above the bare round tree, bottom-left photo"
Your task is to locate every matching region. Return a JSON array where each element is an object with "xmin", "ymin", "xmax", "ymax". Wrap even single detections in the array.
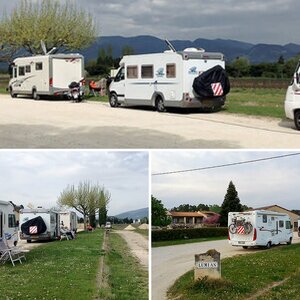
[{"xmin": 0, "ymin": 150, "xmax": 149, "ymax": 215}]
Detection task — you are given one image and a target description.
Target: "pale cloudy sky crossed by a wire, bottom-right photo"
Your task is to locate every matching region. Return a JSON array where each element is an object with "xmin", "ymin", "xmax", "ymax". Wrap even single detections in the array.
[{"xmin": 151, "ymin": 151, "xmax": 300, "ymax": 209}]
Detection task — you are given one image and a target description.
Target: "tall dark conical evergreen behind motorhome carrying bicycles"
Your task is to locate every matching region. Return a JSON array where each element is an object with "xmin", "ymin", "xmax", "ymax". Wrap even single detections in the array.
[{"xmin": 220, "ymin": 181, "xmax": 242, "ymax": 226}]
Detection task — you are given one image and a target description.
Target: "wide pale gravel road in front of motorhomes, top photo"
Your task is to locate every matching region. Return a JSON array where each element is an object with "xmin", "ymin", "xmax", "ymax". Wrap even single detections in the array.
[{"xmin": 0, "ymin": 94, "xmax": 300, "ymax": 149}]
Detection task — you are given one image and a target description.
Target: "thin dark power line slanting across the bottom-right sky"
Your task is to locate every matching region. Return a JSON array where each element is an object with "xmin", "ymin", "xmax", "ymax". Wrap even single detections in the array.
[{"xmin": 152, "ymin": 152, "xmax": 300, "ymax": 176}]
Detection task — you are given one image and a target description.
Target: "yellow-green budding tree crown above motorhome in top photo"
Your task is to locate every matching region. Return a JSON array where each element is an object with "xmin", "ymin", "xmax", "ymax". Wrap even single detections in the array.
[{"xmin": 0, "ymin": 0, "xmax": 96, "ymax": 54}]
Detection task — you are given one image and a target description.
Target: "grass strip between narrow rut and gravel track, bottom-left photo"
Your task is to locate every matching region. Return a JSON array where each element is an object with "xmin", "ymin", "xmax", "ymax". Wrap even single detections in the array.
[{"xmin": 101, "ymin": 232, "xmax": 148, "ymax": 300}]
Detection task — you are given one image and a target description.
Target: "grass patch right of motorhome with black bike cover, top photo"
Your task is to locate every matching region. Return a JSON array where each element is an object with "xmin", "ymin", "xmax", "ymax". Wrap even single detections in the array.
[{"xmin": 224, "ymin": 88, "xmax": 286, "ymax": 118}]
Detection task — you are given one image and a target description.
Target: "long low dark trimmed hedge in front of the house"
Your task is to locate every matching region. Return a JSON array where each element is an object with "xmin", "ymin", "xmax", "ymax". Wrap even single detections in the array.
[{"xmin": 152, "ymin": 227, "xmax": 228, "ymax": 242}]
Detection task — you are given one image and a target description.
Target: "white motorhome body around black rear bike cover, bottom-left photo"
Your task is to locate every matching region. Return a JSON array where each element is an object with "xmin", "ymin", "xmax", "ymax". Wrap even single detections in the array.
[{"xmin": 20, "ymin": 208, "xmax": 60, "ymax": 240}]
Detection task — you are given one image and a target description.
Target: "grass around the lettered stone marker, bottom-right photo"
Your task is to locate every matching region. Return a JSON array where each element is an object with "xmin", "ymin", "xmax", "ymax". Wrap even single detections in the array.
[{"xmin": 168, "ymin": 244, "xmax": 300, "ymax": 300}]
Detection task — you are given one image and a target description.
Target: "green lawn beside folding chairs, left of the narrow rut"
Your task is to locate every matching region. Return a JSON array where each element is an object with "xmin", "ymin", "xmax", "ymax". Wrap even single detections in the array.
[{"xmin": 0, "ymin": 230, "xmax": 103, "ymax": 300}]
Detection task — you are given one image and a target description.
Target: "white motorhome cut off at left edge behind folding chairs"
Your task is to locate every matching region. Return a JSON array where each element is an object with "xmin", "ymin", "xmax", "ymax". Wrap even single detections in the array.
[{"xmin": 0, "ymin": 200, "xmax": 18, "ymax": 245}]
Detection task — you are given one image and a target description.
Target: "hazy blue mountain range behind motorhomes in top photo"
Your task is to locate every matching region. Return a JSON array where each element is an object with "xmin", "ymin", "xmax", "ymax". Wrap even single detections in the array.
[{"xmin": 80, "ymin": 35, "xmax": 300, "ymax": 63}]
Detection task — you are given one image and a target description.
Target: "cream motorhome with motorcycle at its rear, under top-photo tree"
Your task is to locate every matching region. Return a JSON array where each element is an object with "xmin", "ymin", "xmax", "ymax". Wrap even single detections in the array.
[{"xmin": 8, "ymin": 54, "xmax": 84, "ymax": 100}]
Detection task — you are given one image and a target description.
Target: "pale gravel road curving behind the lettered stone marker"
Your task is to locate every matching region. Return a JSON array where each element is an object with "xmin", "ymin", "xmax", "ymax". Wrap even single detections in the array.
[{"xmin": 152, "ymin": 233, "xmax": 300, "ymax": 300}]
